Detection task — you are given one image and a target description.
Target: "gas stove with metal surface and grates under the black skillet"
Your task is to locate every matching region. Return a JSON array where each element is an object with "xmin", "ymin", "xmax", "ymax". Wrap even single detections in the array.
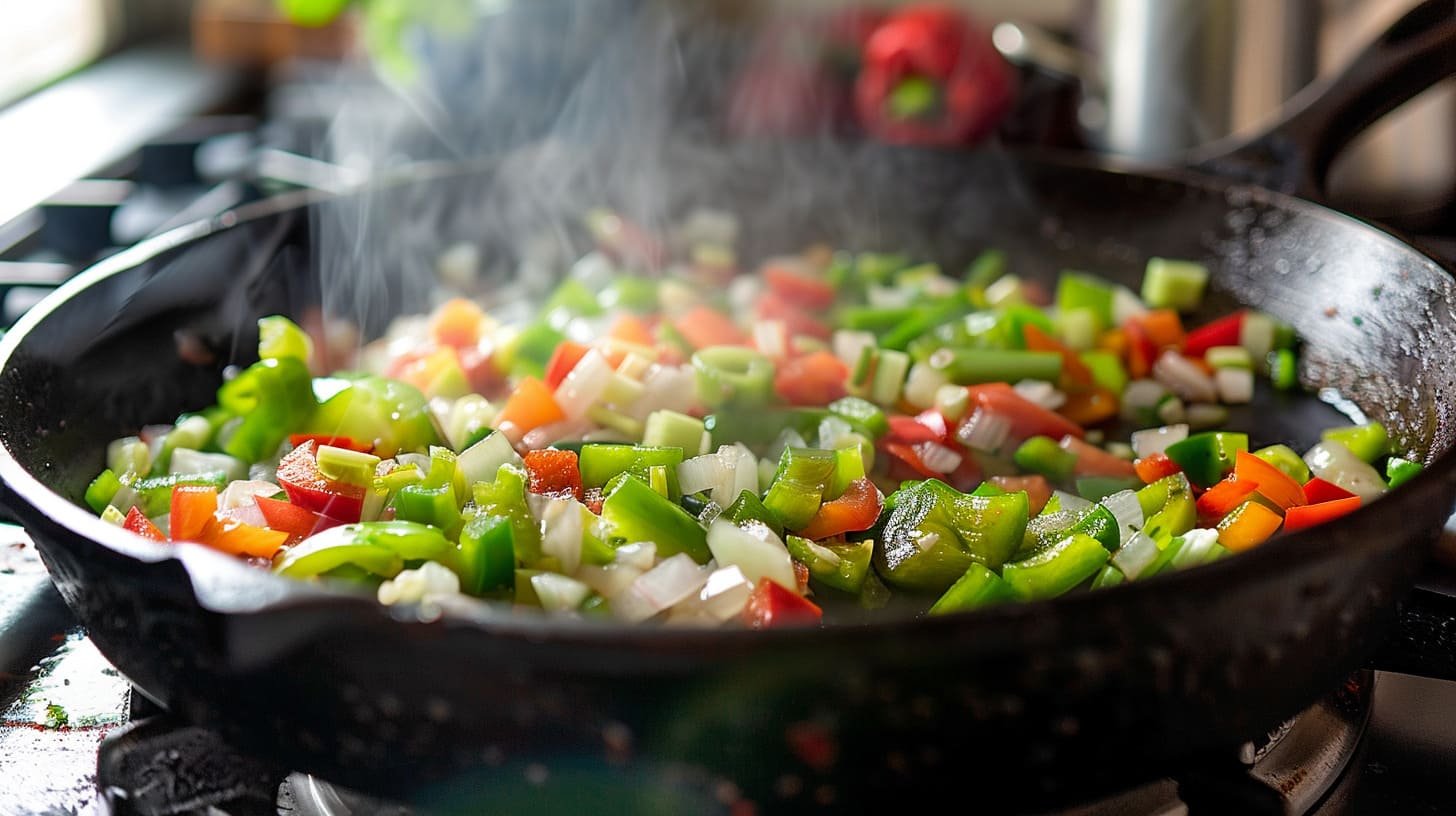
[{"xmin": 0, "ymin": 49, "xmax": 1456, "ymax": 816}]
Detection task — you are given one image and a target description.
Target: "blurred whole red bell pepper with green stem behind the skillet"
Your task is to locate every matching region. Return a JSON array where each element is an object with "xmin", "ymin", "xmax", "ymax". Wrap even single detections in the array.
[{"xmin": 855, "ymin": 4, "xmax": 1016, "ymax": 146}]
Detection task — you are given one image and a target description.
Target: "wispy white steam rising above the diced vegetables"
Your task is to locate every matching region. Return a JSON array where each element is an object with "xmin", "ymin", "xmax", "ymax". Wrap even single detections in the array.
[{"xmin": 304, "ymin": 0, "xmax": 1036, "ymax": 337}]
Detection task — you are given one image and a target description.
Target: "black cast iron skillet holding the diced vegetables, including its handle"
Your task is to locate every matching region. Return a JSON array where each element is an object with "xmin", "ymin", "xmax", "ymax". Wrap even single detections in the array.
[{"xmin": 8, "ymin": 3, "xmax": 1456, "ymax": 813}]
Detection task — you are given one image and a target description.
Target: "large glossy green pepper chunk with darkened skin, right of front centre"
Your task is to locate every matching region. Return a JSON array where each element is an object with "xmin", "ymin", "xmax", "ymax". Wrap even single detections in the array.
[{"xmin": 875, "ymin": 479, "xmax": 1028, "ymax": 593}]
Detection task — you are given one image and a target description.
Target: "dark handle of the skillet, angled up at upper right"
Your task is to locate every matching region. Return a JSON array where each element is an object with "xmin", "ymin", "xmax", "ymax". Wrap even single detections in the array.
[{"xmin": 1192, "ymin": 0, "xmax": 1456, "ymax": 201}]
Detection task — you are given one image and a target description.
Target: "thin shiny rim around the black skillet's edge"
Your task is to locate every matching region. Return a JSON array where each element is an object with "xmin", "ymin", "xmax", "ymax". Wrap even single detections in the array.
[{"xmin": 0, "ymin": 149, "xmax": 1456, "ymax": 654}]
